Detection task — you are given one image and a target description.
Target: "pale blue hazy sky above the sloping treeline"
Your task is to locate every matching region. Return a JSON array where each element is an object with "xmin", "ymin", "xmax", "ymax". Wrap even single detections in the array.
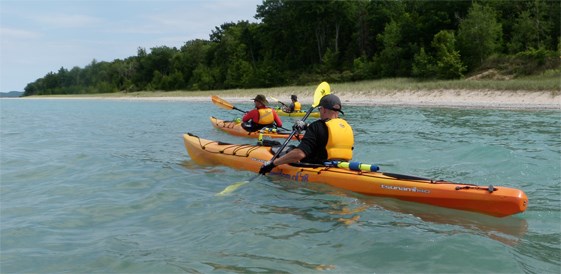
[{"xmin": 0, "ymin": 0, "xmax": 263, "ymax": 92}]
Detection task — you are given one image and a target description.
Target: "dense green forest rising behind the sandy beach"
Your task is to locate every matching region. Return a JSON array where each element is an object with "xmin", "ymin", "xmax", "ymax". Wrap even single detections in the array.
[{"xmin": 20, "ymin": 0, "xmax": 561, "ymax": 96}]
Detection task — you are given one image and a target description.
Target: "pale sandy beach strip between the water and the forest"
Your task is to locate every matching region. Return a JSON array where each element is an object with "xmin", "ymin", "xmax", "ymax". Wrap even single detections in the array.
[{"xmin": 18, "ymin": 89, "xmax": 561, "ymax": 110}]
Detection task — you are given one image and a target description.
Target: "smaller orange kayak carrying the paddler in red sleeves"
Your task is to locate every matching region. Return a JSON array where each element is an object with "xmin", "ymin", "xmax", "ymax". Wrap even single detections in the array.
[{"xmin": 210, "ymin": 117, "xmax": 304, "ymax": 140}]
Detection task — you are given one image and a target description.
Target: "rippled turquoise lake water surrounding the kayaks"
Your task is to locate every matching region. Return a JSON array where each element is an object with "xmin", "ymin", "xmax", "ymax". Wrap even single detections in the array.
[{"xmin": 0, "ymin": 99, "xmax": 561, "ymax": 273}]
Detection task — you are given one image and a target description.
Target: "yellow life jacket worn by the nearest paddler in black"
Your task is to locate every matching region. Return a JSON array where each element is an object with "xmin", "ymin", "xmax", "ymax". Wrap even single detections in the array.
[{"xmin": 325, "ymin": 118, "xmax": 355, "ymax": 161}]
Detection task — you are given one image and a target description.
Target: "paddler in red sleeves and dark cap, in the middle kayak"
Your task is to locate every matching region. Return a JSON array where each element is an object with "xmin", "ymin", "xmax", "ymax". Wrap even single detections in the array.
[{"xmin": 242, "ymin": 94, "xmax": 282, "ymax": 132}]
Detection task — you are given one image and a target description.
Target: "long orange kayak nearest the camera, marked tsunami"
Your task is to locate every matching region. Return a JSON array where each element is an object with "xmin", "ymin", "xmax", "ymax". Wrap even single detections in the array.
[{"xmin": 183, "ymin": 133, "xmax": 528, "ymax": 217}]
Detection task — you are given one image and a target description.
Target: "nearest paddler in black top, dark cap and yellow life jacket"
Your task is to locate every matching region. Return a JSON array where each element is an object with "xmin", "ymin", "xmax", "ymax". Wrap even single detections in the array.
[{"xmin": 259, "ymin": 94, "xmax": 354, "ymax": 174}]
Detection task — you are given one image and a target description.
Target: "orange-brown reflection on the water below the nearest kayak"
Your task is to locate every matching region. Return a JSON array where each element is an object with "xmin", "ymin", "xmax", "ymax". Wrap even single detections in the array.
[{"xmin": 262, "ymin": 179, "xmax": 528, "ymax": 246}]
